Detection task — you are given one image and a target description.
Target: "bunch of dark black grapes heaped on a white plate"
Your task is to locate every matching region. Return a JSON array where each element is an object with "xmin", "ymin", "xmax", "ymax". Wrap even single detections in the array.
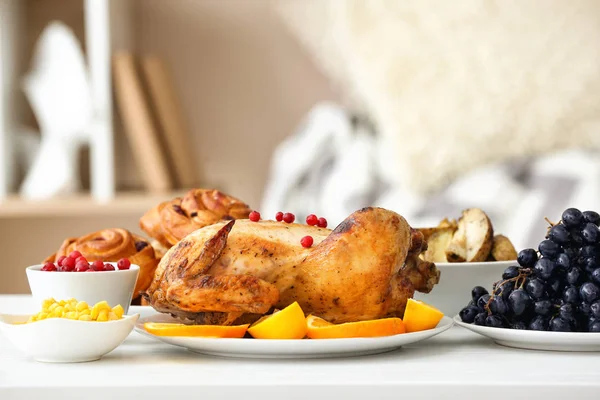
[{"xmin": 459, "ymin": 208, "xmax": 600, "ymax": 332}]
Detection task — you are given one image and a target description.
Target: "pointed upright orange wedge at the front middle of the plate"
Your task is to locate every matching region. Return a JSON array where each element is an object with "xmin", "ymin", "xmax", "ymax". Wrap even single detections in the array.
[{"xmin": 248, "ymin": 302, "xmax": 306, "ymax": 339}]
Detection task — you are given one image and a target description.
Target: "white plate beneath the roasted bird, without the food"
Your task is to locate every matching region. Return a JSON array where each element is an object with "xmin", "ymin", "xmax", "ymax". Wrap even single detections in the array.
[{"xmin": 135, "ymin": 314, "xmax": 453, "ymax": 358}]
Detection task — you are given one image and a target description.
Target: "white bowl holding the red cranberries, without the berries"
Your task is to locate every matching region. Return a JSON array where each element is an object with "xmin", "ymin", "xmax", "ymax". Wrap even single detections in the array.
[{"xmin": 26, "ymin": 263, "xmax": 140, "ymax": 314}]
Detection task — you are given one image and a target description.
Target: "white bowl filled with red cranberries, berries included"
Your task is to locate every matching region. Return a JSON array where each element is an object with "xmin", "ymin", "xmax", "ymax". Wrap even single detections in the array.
[{"xmin": 26, "ymin": 251, "xmax": 140, "ymax": 313}]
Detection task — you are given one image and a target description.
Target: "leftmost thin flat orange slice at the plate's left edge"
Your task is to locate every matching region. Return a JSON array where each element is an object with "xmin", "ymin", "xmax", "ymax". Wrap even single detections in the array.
[{"xmin": 144, "ymin": 322, "xmax": 249, "ymax": 338}]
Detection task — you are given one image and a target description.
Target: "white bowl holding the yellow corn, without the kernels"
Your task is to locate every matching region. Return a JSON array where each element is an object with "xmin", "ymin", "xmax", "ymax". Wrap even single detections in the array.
[{"xmin": 0, "ymin": 314, "xmax": 140, "ymax": 363}]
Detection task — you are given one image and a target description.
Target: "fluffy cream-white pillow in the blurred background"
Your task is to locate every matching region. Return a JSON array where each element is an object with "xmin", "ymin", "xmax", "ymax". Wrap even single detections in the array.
[{"xmin": 275, "ymin": 0, "xmax": 600, "ymax": 194}]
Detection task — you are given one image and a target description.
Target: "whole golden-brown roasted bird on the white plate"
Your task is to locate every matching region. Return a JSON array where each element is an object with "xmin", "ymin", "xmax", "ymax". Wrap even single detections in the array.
[{"xmin": 144, "ymin": 208, "xmax": 440, "ymax": 325}]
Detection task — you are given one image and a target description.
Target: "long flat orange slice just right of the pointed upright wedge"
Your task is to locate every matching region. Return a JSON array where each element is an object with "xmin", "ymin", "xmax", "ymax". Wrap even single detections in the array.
[{"xmin": 306, "ymin": 315, "xmax": 406, "ymax": 339}]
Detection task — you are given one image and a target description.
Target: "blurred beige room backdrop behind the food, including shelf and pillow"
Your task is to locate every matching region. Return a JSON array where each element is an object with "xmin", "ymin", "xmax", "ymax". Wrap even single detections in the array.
[{"xmin": 0, "ymin": 0, "xmax": 600, "ymax": 293}]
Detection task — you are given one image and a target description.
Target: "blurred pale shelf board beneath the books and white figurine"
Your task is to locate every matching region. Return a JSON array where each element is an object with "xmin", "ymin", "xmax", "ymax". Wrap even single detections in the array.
[{"xmin": 0, "ymin": 192, "xmax": 183, "ymax": 218}]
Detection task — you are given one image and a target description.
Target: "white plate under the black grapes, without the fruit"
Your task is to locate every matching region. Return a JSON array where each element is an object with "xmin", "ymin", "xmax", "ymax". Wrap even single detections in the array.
[{"xmin": 454, "ymin": 315, "xmax": 600, "ymax": 352}]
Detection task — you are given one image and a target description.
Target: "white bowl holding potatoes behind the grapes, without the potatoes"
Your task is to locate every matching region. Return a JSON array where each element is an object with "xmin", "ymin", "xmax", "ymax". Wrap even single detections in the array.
[{"xmin": 414, "ymin": 261, "xmax": 518, "ymax": 315}]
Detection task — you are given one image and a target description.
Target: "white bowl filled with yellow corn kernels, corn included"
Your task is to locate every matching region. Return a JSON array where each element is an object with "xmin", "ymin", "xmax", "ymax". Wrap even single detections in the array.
[{"xmin": 0, "ymin": 298, "xmax": 139, "ymax": 363}]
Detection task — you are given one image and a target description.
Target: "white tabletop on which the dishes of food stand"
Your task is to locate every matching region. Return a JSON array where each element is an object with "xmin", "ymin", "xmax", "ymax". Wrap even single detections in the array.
[{"xmin": 0, "ymin": 296, "xmax": 600, "ymax": 400}]
